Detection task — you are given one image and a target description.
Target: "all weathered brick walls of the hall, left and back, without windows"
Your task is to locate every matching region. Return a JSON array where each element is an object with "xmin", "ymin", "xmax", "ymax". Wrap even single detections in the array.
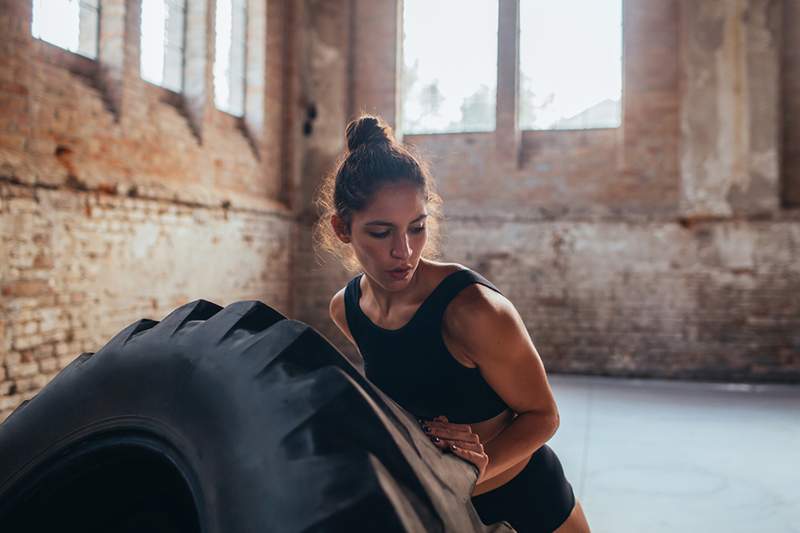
[{"xmin": 0, "ymin": 0, "xmax": 800, "ymax": 419}]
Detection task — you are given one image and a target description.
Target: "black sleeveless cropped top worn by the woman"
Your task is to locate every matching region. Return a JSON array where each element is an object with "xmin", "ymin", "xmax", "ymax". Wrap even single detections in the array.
[{"xmin": 344, "ymin": 269, "xmax": 508, "ymax": 424}]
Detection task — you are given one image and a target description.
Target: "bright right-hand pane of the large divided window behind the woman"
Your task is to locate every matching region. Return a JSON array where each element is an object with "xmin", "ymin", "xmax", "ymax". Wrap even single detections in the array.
[{"xmin": 519, "ymin": 0, "xmax": 622, "ymax": 129}]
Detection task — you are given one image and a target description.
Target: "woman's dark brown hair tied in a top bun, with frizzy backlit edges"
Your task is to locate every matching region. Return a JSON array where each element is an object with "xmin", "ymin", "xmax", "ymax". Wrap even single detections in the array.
[{"xmin": 313, "ymin": 114, "xmax": 442, "ymax": 272}]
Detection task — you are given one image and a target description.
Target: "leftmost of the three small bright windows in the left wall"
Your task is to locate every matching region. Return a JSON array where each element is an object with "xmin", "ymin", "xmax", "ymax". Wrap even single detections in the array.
[{"xmin": 31, "ymin": 0, "xmax": 100, "ymax": 59}]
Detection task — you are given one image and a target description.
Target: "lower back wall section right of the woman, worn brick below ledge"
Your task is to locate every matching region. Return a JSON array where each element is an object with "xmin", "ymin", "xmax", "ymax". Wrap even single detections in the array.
[{"xmin": 445, "ymin": 217, "xmax": 800, "ymax": 382}]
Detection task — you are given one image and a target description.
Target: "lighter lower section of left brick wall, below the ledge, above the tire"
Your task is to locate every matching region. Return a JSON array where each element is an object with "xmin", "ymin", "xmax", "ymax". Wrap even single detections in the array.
[{"xmin": 0, "ymin": 184, "xmax": 292, "ymax": 418}]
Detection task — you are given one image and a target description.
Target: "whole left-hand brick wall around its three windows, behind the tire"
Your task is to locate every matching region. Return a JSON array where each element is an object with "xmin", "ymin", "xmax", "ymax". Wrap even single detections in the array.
[{"xmin": 0, "ymin": 0, "xmax": 299, "ymax": 420}]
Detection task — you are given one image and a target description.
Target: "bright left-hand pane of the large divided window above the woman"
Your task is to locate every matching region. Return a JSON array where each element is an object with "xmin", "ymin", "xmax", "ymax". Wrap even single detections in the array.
[{"xmin": 402, "ymin": 0, "xmax": 498, "ymax": 133}]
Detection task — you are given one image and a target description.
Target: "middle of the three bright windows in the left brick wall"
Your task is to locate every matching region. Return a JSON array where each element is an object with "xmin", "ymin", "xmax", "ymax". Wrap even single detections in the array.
[{"xmin": 139, "ymin": 0, "xmax": 186, "ymax": 92}]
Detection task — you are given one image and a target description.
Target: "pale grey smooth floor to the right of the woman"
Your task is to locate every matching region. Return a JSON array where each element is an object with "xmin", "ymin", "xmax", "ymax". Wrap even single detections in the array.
[{"xmin": 548, "ymin": 375, "xmax": 800, "ymax": 533}]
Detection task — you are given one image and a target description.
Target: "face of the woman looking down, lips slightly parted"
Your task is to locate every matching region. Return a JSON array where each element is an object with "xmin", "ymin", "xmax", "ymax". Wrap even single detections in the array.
[{"xmin": 334, "ymin": 183, "xmax": 428, "ymax": 290}]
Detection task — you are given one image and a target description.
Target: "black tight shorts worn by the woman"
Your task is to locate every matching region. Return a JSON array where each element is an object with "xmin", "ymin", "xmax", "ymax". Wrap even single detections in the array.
[{"xmin": 472, "ymin": 444, "xmax": 575, "ymax": 533}]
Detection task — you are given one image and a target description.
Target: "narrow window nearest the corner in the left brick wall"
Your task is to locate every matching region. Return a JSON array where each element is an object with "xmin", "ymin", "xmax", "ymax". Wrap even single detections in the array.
[{"xmin": 214, "ymin": 0, "xmax": 247, "ymax": 116}]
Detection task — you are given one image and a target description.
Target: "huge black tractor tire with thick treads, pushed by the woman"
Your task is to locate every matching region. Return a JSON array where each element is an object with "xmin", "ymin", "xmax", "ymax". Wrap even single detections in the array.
[{"xmin": 0, "ymin": 300, "xmax": 513, "ymax": 533}]
